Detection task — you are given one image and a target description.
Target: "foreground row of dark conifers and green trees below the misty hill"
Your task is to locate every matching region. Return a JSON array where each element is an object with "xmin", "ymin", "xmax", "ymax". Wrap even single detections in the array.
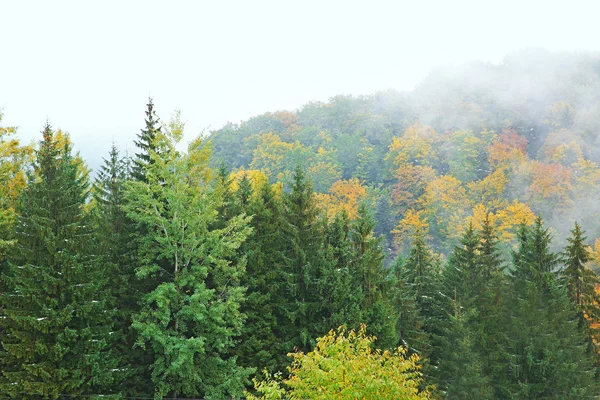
[{"xmin": 0, "ymin": 100, "xmax": 600, "ymax": 399}]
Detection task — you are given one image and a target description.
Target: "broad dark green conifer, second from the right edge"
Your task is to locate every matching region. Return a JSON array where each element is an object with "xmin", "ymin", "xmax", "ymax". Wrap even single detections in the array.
[{"xmin": 499, "ymin": 217, "xmax": 597, "ymax": 399}]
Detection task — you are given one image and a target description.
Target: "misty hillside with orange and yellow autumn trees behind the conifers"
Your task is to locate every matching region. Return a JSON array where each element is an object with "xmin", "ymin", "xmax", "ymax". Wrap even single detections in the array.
[{"xmin": 210, "ymin": 49, "xmax": 600, "ymax": 253}]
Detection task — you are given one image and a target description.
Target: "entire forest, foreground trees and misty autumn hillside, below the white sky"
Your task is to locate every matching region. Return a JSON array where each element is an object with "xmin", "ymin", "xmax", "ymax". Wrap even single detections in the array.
[{"xmin": 0, "ymin": 51, "xmax": 600, "ymax": 399}]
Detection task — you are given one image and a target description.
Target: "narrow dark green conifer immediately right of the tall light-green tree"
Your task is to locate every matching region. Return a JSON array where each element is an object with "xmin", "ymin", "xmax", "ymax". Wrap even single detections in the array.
[{"xmin": 235, "ymin": 176, "xmax": 290, "ymax": 372}]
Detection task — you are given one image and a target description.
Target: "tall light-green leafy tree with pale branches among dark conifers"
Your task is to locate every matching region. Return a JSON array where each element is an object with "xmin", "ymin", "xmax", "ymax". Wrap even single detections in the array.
[{"xmin": 125, "ymin": 135, "xmax": 250, "ymax": 399}]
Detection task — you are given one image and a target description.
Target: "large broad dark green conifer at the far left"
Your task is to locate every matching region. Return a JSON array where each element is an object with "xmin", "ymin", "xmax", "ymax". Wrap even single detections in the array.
[{"xmin": 0, "ymin": 125, "xmax": 116, "ymax": 399}]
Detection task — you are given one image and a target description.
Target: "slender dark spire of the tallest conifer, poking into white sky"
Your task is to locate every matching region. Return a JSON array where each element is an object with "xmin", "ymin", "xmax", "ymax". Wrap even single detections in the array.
[{"xmin": 132, "ymin": 97, "xmax": 162, "ymax": 182}]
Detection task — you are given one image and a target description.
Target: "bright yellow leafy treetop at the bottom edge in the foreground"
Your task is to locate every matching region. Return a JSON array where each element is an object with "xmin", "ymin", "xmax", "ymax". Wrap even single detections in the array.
[{"xmin": 247, "ymin": 325, "xmax": 432, "ymax": 400}]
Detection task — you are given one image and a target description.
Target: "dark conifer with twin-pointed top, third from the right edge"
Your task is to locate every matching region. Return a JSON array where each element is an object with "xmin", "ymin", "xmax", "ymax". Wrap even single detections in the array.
[{"xmin": 437, "ymin": 215, "xmax": 505, "ymax": 398}]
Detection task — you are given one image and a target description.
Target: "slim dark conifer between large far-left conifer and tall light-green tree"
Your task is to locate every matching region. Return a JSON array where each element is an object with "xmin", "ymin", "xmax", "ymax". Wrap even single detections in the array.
[{"xmin": 93, "ymin": 145, "xmax": 152, "ymax": 396}]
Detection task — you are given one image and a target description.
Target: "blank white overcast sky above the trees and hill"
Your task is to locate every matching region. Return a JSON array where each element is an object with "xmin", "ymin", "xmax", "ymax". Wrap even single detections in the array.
[{"xmin": 0, "ymin": 0, "xmax": 600, "ymax": 168}]
